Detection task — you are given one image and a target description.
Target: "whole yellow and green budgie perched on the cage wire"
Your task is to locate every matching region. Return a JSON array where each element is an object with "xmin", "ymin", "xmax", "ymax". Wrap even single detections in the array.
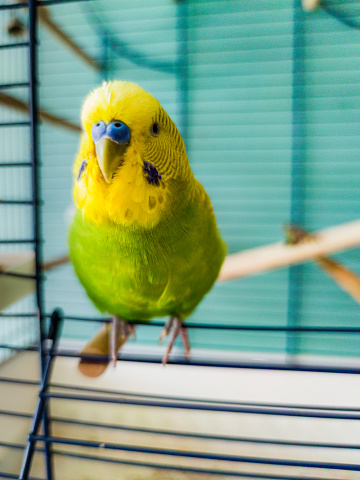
[{"xmin": 68, "ymin": 80, "xmax": 226, "ymax": 364}]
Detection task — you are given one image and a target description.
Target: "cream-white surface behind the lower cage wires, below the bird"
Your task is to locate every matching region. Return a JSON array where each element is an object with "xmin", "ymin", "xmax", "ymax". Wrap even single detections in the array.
[{"xmin": 0, "ymin": 354, "xmax": 360, "ymax": 480}]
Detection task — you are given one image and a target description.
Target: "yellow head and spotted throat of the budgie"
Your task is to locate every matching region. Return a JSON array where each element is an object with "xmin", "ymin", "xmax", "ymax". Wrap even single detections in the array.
[{"xmin": 74, "ymin": 81, "xmax": 192, "ymax": 226}]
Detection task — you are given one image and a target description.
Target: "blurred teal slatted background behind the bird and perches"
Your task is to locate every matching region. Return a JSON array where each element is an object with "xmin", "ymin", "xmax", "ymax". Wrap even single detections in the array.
[{"xmin": 0, "ymin": 0, "xmax": 360, "ymax": 356}]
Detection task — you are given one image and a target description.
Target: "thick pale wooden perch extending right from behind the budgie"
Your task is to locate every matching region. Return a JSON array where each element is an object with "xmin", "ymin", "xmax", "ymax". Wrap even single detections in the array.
[{"xmin": 218, "ymin": 220, "xmax": 360, "ymax": 281}]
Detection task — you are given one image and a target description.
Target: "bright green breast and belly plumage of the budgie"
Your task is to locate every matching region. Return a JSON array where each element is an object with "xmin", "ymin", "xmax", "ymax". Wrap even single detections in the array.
[{"xmin": 69, "ymin": 182, "xmax": 226, "ymax": 320}]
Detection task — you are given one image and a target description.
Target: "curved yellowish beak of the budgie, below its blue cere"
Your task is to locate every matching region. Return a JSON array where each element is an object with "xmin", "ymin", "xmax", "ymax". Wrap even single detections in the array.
[{"xmin": 95, "ymin": 136, "xmax": 128, "ymax": 183}]
